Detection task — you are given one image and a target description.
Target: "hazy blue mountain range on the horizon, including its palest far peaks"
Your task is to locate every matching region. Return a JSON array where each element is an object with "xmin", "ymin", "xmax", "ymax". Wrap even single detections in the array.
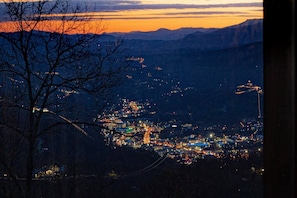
[{"xmin": 102, "ymin": 19, "xmax": 263, "ymax": 55}]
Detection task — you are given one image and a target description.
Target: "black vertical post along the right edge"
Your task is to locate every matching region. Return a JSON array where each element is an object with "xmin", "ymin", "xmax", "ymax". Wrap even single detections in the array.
[{"xmin": 263, "ymin": 0, "xmax": 297, "ymax": 198}]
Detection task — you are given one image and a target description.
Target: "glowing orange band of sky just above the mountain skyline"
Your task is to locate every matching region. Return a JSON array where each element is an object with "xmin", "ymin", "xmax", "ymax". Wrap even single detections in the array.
[{"xmin": 0, "ymin": 0, "xmax": 263, "ymax": 34}]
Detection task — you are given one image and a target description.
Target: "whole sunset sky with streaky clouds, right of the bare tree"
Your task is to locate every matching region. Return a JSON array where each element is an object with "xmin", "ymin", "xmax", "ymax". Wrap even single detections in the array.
[{"xmin": 0, "ymin": 0, "xmax": 263, "ymax": 33}]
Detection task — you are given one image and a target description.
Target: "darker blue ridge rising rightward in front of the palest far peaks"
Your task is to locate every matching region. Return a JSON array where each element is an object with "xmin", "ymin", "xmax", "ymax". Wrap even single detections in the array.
[{"xmin": 114, "ymin": 19, "xmax": 263, "ymax": 55}]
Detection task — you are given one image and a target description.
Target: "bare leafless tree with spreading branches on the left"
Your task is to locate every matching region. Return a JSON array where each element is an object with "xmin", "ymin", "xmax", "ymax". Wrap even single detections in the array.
[{"xmin": 0, "ymin": 0, "xmax": 127, "ymax": 197}]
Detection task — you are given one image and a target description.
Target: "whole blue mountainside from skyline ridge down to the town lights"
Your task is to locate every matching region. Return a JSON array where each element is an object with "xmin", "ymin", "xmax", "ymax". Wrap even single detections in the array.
[{"xmin": 106, "ymin": 20, "xmax": 263, "ymax": 123}]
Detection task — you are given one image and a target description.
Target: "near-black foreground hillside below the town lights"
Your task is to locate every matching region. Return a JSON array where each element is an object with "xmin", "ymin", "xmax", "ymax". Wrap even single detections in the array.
[{"xmin": 0, "ymin": 128, "xmax": 263, "ymax": 198}]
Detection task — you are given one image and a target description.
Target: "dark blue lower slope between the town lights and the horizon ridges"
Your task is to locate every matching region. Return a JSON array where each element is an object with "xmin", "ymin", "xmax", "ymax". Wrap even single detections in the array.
[{"xmin": 117, "ymin": 42, "xmax": 263, "ymax": 123}]
